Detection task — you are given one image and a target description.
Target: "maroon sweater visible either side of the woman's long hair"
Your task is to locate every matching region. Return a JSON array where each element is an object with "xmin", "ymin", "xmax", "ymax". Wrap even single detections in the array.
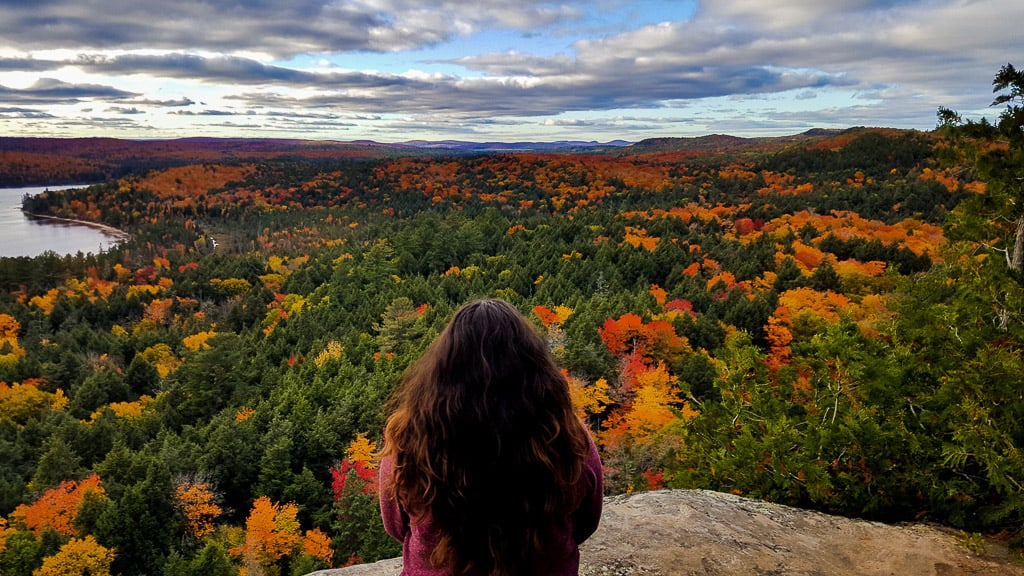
[{"xmin": 379, "ymin": 435, "xmax": 604, "ymax": 576}]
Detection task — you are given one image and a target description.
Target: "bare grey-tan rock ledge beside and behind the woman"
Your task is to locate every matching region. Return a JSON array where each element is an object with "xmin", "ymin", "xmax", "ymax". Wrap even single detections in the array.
[{"xmin": 315, "ymin": 490, "xmax": 1024, "ymax": 576}]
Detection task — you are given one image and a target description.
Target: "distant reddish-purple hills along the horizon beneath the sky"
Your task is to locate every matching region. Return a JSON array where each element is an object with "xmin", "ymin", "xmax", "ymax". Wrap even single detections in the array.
[{"xmin": 0, "ymin": 128, "xmax": 921, "ymax": 188}]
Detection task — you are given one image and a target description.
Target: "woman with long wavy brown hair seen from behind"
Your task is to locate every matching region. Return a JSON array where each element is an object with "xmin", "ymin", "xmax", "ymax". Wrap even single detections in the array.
[{"xmin": 380, "ymin": 299, "xmax": 603, "ymax": 576}]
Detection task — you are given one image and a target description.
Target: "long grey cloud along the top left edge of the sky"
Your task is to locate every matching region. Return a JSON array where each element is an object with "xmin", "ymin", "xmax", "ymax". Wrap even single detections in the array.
[{"xmin": 0, "ymin": 0, "xmax": 579, "ymax": 57}]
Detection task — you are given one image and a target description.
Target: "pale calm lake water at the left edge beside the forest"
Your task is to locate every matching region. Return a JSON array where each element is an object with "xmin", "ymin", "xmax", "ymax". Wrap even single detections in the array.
[{"xmin": 0, "ymin": 186, "xmax": 118, "ymax": 256}]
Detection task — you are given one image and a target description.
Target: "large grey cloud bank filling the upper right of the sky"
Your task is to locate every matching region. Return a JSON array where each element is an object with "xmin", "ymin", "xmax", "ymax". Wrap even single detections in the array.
[{"xmin": 430, "ymin": 0, "xmax": 1024, "ymax": 118}]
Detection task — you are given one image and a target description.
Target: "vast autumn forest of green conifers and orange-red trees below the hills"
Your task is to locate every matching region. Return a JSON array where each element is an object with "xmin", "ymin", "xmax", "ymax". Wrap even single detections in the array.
[{"xmin": 0, "ymin": 65, "xmax": 1024, "ymax": 576}]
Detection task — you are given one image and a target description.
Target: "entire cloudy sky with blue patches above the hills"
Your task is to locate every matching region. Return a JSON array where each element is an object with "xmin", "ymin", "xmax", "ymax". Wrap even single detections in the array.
[{"xmin": 0, "ymin": 0, "xmax": 1024, "ymax": 142}]
